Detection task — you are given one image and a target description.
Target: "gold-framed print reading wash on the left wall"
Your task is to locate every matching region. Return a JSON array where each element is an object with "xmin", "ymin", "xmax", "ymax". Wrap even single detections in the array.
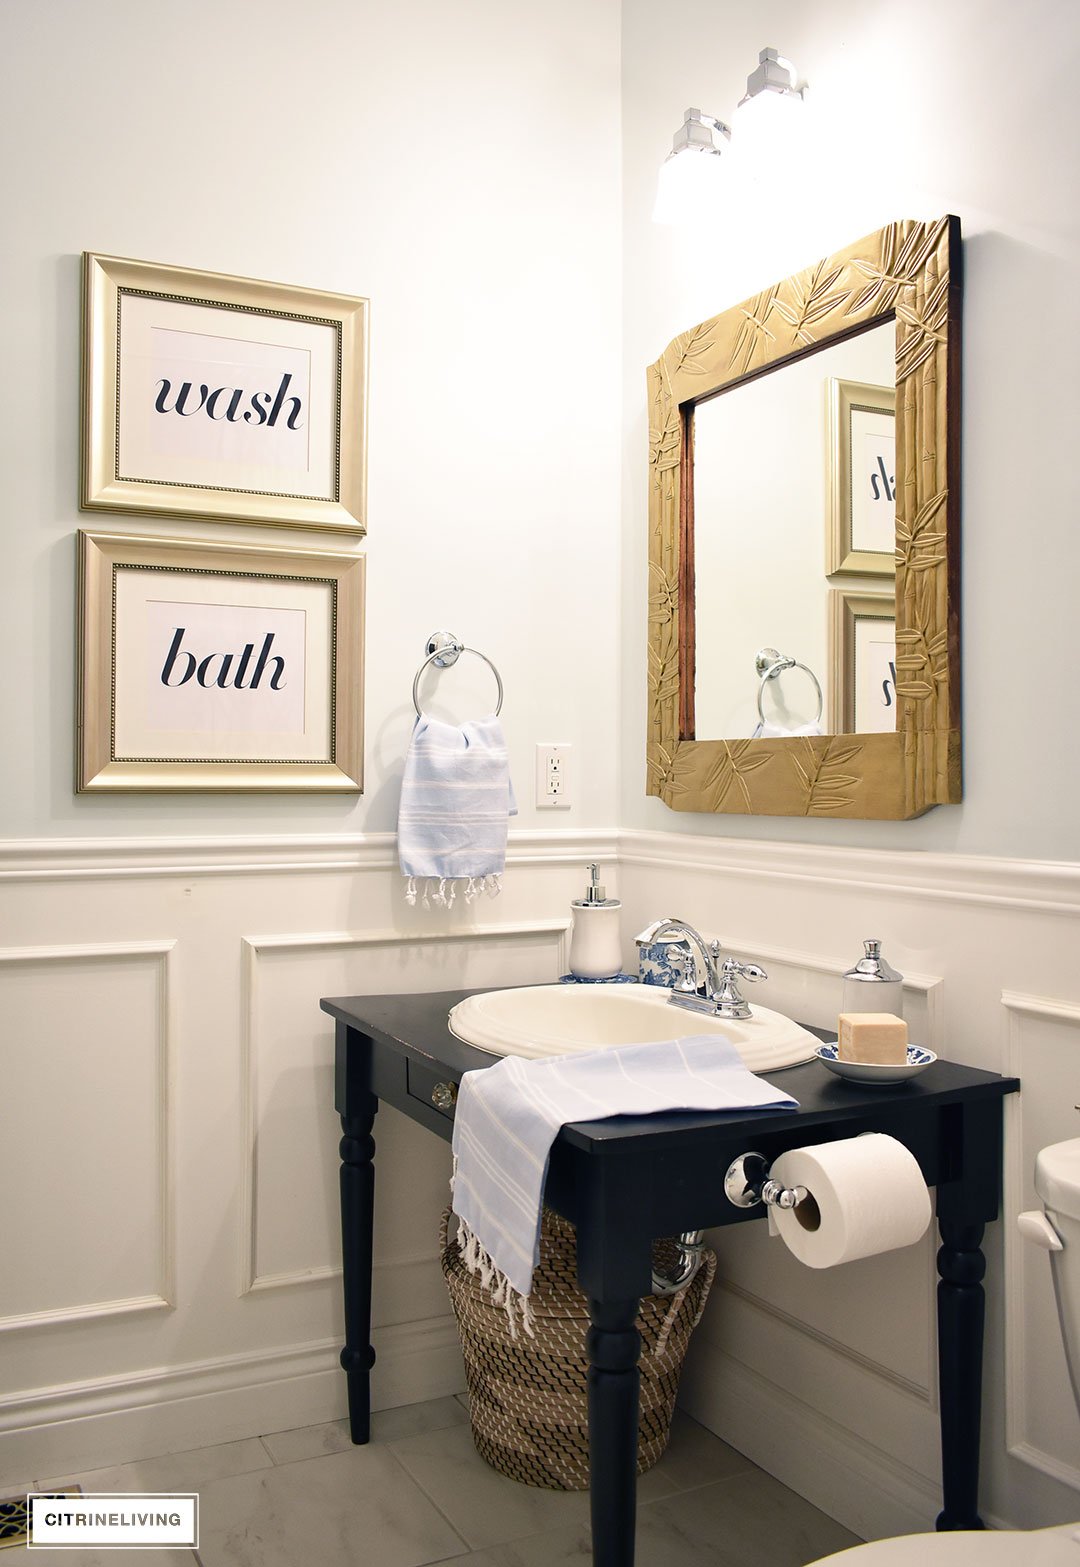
[{"xmin": 80, "ymin": 251, "xmax": 368, "ymax": 536}]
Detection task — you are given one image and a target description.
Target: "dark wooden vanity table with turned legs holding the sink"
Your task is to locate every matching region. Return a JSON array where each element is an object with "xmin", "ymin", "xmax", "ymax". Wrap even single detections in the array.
[{"xmin": 321, "ymin": 990, "xmax": 1020, "ymax": 1567}]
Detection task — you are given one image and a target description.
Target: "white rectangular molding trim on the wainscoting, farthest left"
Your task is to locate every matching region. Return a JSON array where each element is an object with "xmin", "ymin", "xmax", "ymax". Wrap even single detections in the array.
[{"xmin": 0, "ymin": 940, "xmax": 176, "ymax": 1334}]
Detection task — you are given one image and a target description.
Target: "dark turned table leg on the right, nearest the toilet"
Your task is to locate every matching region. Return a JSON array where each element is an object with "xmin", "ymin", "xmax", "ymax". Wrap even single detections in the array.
[{"xmin": 937, "ymin": 1219, "xmax": 986, "ymax": 1529}]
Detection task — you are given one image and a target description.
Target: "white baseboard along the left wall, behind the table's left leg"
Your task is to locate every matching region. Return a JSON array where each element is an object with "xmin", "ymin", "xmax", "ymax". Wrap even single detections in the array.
[{"xmin": 0, "ymin": 1315, "xmax": 466, "ymax": 1486}]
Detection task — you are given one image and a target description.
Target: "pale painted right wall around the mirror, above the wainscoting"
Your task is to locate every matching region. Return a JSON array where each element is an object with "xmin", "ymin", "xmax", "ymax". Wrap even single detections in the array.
[{"xmin": 619, "ymin": 0, "xmax": 1080, "ymax": 860}]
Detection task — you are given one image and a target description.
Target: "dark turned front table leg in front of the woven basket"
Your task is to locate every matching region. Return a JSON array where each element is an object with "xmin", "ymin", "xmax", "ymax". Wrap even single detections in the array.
[{"xmin": 586, "ymin": 1299, "xmax": 641, "ymax": 1567}]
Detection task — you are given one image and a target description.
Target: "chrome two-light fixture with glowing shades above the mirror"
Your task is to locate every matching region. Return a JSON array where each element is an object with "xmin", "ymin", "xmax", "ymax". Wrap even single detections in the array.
[{"xmin": 652, "ymin": 49, "xmax": 806, "ymax": 224}]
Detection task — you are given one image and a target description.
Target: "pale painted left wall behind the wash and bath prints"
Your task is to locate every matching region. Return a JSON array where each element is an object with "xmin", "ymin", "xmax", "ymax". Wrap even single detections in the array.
[{"xmin": 0, "ymin": 0, "xmax": 621, "ymax": 838}]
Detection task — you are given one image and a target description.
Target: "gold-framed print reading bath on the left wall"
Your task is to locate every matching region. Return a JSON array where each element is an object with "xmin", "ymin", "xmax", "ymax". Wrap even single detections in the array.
[{"xmin": 75, "ymin": 530, "xmax": 365, "ymax": 793}]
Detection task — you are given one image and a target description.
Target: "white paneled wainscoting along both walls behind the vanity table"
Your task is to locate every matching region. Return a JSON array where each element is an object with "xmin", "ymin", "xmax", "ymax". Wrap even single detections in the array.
[{"xmin": 0, "ymin": 831, "xmax": 1080, "ymax": 1536}]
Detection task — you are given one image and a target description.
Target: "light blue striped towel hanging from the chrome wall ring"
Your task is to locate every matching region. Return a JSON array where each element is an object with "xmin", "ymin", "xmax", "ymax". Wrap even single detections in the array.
[{"xmin": 398, "ymin": 715, "xmax": 517, "ymax": 909}]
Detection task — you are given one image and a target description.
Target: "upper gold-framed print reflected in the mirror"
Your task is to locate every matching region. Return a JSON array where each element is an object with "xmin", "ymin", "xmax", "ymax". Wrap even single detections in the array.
[{"xmin": 824, "ymin": 378, "xmax": 897, "ymax": 577}]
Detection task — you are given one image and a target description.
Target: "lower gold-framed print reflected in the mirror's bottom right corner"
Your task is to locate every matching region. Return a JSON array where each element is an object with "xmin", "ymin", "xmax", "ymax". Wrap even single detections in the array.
[{"xmin": 829, "ymin": 589, "xmax": 897, "ymax": 735}]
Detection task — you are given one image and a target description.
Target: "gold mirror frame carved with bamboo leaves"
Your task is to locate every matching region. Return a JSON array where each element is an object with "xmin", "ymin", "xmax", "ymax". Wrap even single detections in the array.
[{"xmin": 647, "ymin": 216, "xmax": 961, "ymax": 820}]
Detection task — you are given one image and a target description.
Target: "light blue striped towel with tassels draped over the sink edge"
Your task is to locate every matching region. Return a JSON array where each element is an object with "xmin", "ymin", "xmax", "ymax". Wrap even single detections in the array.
[{"xmin": 451, "ymin": 1034, "xmax": 798, "ymax": 1329}]
